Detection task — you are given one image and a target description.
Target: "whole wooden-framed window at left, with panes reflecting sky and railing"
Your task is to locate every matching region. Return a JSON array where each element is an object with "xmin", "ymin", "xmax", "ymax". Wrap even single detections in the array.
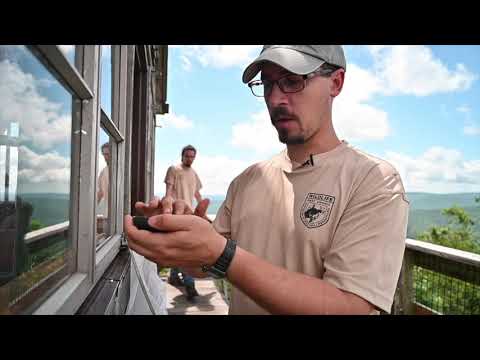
[{"xmin": 0, "ymin": 45, "xmax": 161, "ymax": 314}]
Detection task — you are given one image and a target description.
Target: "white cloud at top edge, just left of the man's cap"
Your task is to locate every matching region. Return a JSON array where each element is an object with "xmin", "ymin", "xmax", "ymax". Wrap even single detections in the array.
[{"xmin": 174, "ymin": 45, "xmax": 262, "ymax": 69}]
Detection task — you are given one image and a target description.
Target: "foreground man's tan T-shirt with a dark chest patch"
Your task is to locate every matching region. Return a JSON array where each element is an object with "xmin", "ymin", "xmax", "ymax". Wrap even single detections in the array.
[{"xmin": 214, "ymin": 142, "xmax": 408, "ymax": 314}]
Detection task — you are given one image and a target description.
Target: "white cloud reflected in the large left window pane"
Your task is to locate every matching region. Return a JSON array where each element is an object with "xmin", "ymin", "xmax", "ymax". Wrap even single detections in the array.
[{"xmin": 0, "ymin": 60, "xmax": 71, "ymax": 149}]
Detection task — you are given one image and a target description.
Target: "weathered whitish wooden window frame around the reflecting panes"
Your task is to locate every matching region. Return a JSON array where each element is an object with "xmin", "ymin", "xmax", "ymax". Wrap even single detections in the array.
[{"xmin": 31, "ymin": 45, "xmax": 134, "ymax": 314}]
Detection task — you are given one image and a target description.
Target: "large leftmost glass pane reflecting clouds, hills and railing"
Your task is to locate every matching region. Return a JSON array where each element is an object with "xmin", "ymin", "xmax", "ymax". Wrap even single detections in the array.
[{"xmin": 0, "ymin": 46, "xmax": 74, "ymax": 314}]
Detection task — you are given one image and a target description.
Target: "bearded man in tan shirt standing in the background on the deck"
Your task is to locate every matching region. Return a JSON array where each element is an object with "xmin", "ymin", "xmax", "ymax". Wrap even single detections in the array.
[{"xmin": 165, "ymin": 145, "xmax": 202, "ymax": 300}]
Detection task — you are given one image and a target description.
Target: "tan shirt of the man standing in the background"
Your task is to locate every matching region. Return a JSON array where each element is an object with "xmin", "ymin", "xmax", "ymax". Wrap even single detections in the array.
[{"xmin": 165, "ymin": 164, "xmax": 202, "ymax": 207}]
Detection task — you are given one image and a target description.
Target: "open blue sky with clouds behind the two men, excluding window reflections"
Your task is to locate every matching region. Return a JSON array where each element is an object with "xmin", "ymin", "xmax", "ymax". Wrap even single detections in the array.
[{"xmin": 155, "ymin": 45, "xmax": 480, "ymax": 195}]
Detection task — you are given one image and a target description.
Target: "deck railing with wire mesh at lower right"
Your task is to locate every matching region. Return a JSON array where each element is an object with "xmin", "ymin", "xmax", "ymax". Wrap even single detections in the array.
[{"xmin": 392, "ymin": 239, "xmax": 480, "ymax": 315}]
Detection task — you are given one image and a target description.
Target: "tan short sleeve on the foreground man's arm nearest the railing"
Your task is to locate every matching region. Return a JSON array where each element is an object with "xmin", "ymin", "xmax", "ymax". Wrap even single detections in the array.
[{"xmin": 323, "ymin": 163, "xmax": 409, "ymax": 312}]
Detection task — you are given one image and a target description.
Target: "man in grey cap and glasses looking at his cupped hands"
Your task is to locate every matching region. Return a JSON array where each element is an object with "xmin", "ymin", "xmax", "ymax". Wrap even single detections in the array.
[{"xmin": 125, "ymin": 45, "xmax": 408, "ymax": 314}]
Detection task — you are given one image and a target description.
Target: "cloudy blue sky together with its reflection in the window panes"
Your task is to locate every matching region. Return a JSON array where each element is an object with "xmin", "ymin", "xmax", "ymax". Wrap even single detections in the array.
[{"xmin": 0, "ymin": 45, "xmax": 480, "ymax": 200}]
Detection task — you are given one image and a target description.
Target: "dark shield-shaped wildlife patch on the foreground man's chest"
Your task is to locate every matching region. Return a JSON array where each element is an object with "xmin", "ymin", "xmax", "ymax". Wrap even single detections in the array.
[{"xmin": 300, "ymin": 193, "xmax": 335, "ymax": 228}]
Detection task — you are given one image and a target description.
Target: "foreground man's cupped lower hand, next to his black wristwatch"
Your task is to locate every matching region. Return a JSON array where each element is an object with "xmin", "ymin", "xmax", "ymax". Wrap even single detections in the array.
[{"xmin": 124, "ymin": 214, "xmax": 227, "ymax": 270}]
